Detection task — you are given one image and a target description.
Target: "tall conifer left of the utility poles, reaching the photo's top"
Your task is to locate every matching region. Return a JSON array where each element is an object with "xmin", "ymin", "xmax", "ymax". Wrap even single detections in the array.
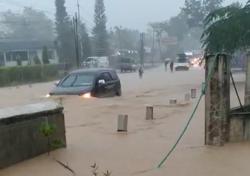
[{"xmin": 55, "ymin": 0, "xmax": 76, "ymax": 64}]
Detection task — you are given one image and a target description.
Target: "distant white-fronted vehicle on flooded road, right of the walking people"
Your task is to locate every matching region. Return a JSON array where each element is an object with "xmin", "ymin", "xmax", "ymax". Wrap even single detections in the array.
[{"xmin": 174, "ymin": 54, "xmax": 190, "ymax": 71}]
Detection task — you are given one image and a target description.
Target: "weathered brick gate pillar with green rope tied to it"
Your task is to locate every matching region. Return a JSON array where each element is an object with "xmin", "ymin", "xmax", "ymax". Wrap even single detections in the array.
[{"xmin": 205, "ymin": 54, "xmax": 230, "ymax": 146}]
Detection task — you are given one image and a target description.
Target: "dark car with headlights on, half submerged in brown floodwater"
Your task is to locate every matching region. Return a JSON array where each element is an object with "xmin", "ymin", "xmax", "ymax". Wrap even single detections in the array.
[{"xmin": 50, "ymin": 69, "xmax": 122, "ymax": 98}]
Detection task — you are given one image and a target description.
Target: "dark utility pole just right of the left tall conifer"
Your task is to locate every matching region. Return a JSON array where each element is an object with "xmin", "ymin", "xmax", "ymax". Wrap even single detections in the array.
[{"xmin": 73, "ymin": 13, "xmax": 80, "ymax": 68}]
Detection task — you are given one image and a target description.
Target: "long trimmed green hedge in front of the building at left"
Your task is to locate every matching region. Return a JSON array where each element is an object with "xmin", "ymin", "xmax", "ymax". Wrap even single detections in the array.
[{"xmin": 0, "ymin": 65, "xmax": 59, "ymax": 87}]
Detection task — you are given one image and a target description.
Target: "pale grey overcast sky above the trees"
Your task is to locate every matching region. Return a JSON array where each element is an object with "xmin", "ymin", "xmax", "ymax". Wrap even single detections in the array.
[{"xmin": 0, "ymin": 0, "xmax": 247, "ymax": 30}]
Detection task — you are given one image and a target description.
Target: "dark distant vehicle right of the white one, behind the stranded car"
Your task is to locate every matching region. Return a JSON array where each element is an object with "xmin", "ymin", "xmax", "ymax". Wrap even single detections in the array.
[{"xmin": 119, "ymin": 57, "xmax": 137, "ymax": 72}]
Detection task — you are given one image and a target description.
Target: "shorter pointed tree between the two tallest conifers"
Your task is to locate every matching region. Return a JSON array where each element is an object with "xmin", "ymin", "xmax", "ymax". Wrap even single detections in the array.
[{"xmin": 79, "ymin": 23, "xmax": 92, "ymax": 59}]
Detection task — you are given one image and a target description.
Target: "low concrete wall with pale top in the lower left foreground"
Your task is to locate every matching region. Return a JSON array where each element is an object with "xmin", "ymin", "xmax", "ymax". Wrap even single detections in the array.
[{"xmin": 0, "ymin": 102, "xmax": 66, "ymax": 168}]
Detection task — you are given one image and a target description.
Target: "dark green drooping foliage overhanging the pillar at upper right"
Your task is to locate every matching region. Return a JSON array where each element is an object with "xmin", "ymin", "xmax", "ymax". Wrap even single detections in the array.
[{"xmin": 201, "ymin": 3, "xmax": 250, "ymax": 53}]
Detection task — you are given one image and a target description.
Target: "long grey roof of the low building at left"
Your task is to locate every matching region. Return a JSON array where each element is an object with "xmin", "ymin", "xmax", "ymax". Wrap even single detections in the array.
[{"xmin": 0, "ymin": 40, "xmax": 55, "ymax": 51}]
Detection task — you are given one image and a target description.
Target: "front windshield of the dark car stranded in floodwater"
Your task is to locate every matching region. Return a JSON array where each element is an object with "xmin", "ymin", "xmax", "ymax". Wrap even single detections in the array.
[{"xmin": 61, "ymin": 73, "xmax": 94, "ymax": 87}]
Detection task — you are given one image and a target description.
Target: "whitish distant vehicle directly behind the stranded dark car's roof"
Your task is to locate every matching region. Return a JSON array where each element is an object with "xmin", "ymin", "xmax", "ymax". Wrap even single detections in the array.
[{"xmin": 82, "ymin": 56, "xmax": 109, "ymax": 68}]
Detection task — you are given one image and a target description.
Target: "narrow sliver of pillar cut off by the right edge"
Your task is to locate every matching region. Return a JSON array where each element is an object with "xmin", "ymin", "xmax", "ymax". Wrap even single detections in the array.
[{"xmin": 245, "ymin": 51, "xmax": 250, "ymax": 105}]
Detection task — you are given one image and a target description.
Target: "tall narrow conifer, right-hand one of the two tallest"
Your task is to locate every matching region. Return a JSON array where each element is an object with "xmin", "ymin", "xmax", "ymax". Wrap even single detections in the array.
[{"xmin": 93, "ymin": 0, "xmax": 109, "ymax": 56}]
